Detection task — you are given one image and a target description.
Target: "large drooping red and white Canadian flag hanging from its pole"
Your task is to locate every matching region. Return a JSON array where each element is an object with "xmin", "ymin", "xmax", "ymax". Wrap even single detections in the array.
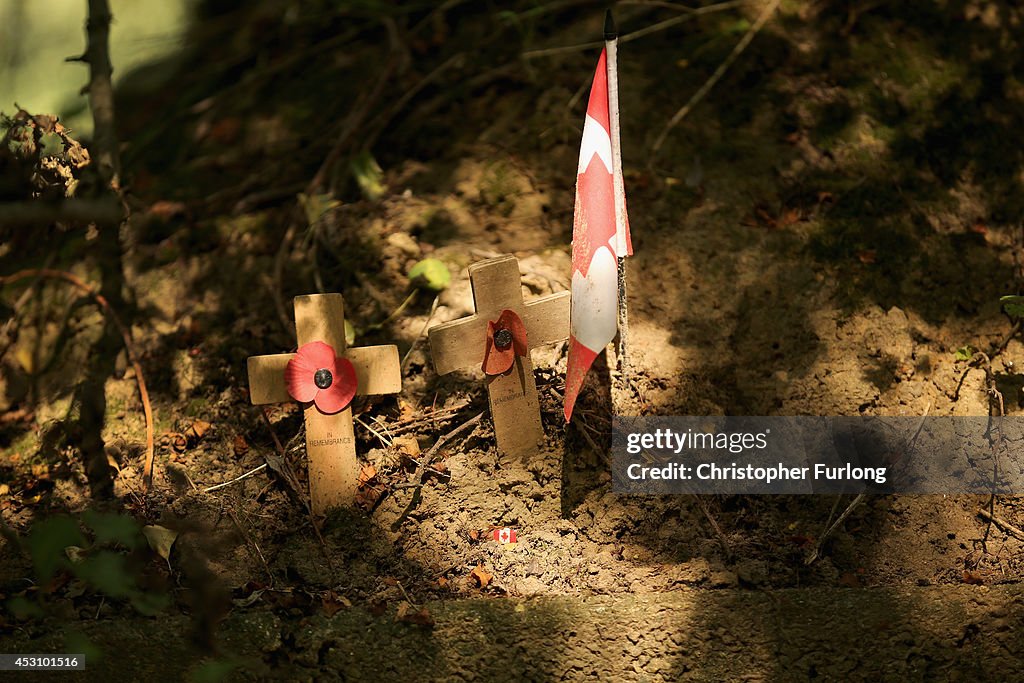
[{"xmin": 564, "ymin": 50, "xmax": 633, "ymax": 422}]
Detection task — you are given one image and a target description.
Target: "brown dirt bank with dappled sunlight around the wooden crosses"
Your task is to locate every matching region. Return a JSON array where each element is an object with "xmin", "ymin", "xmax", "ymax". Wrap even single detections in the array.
[{"xmin": 0, "ymin": 2, "xmax": 1024, "ymax": 680}]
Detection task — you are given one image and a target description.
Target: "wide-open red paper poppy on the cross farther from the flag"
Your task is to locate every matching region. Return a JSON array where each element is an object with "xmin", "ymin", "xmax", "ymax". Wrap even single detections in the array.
[{"xmin": 285, "ymin": 342, "xmax": 355, "ymax": 415}]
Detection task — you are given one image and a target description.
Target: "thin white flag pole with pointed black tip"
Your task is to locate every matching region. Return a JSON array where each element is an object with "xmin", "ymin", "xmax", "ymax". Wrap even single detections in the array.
[{"xmin": 604, "ymin": 8, "xmax": 630, "ymax": 401}]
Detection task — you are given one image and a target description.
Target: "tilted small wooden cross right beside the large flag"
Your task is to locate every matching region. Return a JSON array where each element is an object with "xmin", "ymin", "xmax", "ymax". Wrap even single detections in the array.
[{"xmin": 429, "ymin": 255, "xmax": 569, "ymax": 456}]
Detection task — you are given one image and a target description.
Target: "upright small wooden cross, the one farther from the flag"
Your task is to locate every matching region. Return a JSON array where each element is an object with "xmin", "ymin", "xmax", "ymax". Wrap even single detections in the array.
[{"xmin": 249, "ymin": 294, "xmax": 401, "ymax": 514}]
